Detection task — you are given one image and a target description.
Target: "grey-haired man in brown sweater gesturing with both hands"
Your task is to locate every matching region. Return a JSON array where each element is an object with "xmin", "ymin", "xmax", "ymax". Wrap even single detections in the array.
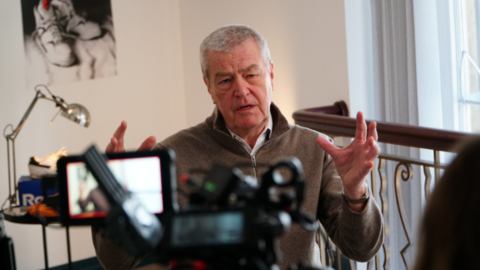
[{"xmin": 93, "ymin": 25, "xmax": 383, "ymax": 269}]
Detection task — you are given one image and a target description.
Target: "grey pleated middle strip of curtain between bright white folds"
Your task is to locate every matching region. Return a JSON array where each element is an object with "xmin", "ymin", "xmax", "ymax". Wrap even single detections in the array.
[{"xmin": 371, "ymin": 0, "xmax": 421, "ymax": 269}]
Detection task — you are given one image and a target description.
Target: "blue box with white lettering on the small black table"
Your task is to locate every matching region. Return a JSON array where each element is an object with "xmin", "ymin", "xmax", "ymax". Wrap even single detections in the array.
[{"xmin": 18, "ymin": 175, "xmax": 57, "ymax": 206}]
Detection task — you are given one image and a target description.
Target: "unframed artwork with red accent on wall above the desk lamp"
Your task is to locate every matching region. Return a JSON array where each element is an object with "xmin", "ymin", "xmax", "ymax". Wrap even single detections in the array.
[{"xmin": 21, "ymin": 0, "xmax": 117, "ymax": 88}]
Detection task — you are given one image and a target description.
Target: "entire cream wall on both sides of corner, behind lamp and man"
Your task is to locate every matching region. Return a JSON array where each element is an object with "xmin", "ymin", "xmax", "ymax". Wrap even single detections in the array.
[{"xmin": 0, "ymin": 0, "xmax": 349, "ymax": 269}]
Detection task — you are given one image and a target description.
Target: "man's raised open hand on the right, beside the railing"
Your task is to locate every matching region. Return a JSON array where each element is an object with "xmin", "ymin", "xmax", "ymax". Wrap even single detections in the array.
[{"xmin": 317, "ymin": 112, "xmax": 380, "ymax": 207}]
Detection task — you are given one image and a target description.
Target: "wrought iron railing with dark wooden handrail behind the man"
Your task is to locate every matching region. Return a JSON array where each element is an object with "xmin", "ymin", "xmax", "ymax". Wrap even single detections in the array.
[{"xmin": 293, "ymin": 101, "xmax": 470, "ymax": 270}]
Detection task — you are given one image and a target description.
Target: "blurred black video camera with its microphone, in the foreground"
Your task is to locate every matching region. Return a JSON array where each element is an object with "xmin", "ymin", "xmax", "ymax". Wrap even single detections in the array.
[{"xmin": 59, "ymin": 146, "xmax": 332, "ymax": 270}]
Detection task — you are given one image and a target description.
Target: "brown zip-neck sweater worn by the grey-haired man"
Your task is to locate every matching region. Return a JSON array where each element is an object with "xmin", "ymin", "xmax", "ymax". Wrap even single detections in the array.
[{"xmin": 93, "ymin": 104, "xmax": 383, "ymax": 269}]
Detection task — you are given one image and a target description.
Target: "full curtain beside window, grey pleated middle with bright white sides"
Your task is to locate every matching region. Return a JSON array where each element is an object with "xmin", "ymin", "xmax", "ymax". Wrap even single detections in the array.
[{"xmin": 345, "ymin": 0, "xmax": 454, "ymax": 269}]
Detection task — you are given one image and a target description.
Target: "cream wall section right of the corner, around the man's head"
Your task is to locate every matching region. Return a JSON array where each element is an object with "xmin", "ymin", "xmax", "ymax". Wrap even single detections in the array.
[{"xmin": 180, "ymin": 0, "xmax": 349, "ymax": 125}]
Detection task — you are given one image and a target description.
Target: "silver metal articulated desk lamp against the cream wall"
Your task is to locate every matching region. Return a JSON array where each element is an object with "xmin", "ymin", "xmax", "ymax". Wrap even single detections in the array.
[{"xmin": 2, "ymin": 85, "xmax": 90, "ymax": 209}]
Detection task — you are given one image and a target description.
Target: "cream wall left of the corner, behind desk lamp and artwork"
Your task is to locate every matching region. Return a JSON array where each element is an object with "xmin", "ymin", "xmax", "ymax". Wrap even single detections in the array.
[{"xmin": 0, "ymin": 0, "xmax": 186, "ymax": 269}]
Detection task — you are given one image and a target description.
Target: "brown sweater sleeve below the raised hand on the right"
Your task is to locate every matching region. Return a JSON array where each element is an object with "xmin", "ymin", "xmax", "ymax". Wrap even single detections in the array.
[{"xmin": 317, "ymin": 153, "xmax": 384, "ymax": 262}]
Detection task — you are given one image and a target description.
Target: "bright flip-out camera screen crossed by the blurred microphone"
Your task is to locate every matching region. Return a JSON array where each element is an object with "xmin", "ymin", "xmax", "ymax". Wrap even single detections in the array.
[{"xmin": 57, "ymin": 150, "xmax": 176, "ymax": 225}]
